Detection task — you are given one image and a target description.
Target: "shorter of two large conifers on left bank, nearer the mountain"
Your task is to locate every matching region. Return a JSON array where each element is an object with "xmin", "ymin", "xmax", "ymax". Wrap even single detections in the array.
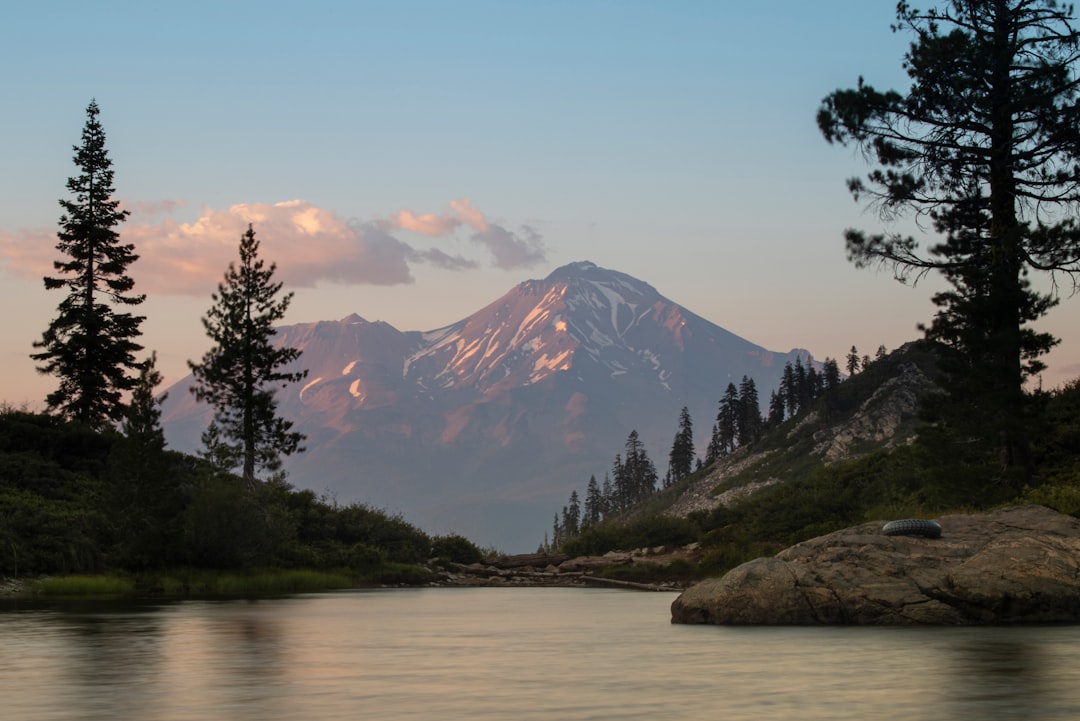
[{"xmin": 188, "ymin": 226, "xmax": 307, "ymax": 490}]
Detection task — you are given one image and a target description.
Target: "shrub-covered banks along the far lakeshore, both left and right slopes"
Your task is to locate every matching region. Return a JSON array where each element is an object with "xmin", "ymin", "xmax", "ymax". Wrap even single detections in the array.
[{"xmin": 6, "ymin": 345, "xmax": 1080, "ymax": 599}]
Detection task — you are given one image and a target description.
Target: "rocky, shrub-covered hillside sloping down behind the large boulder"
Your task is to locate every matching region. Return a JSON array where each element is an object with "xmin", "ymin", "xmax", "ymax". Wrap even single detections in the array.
[{"xmin": 552, "ymin": 341, "xmax": 1080, "ymax": 582}]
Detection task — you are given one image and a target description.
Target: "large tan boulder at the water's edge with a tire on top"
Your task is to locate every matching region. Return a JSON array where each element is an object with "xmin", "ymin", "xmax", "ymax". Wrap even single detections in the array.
[{"xmin": 672, "ymin": 506, "xmax": 1080, "ymax": 625}]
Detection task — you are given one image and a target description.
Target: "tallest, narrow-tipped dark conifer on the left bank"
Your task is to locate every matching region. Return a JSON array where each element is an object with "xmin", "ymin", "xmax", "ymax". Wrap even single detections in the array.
[{"xmin": 30, "ymin": 101, "xmax": 146, "ymax": 427}]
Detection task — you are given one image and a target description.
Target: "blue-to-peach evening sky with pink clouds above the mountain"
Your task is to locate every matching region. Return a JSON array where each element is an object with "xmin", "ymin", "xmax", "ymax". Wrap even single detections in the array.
[{"xmin": 0, "ymin": 0, "xmax": 1080, "ymax": 409}]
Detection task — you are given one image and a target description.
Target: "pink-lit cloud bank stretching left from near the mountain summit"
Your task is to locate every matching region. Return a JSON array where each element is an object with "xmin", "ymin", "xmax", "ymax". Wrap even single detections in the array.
[{"xmin": 0, "ymin": 199, "xmax": 546, "ymax": 296}]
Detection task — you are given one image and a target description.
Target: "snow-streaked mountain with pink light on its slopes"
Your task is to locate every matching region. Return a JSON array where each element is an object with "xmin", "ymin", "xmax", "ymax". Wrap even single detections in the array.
[{"xmin": 163, "ymin": 262, "xmax": 807, "ymax": 552}]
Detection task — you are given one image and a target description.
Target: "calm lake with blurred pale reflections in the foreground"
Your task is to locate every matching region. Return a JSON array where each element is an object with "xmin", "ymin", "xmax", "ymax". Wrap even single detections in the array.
[{"xmin": 0, "ymin": 588, "xmax": 1080, "ymax": 721}]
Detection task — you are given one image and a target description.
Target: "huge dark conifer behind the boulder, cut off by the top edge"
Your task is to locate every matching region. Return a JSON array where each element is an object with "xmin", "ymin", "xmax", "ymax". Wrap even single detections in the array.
[{"xmin": 818, "ymin": 0, "xmax": 1080, "ymax": 468}]
